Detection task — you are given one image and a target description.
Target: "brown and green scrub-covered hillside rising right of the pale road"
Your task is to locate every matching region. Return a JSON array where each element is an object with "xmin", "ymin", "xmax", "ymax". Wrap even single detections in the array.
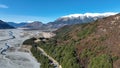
[{"xmin": 25, "ymin": 14, "xmax": 120, "ymax": 68}]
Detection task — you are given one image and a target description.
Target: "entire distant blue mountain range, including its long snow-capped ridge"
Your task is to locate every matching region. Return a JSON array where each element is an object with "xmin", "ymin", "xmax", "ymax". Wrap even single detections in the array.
[{"xmin": 1, "ymin": 13, "xmax": 116, "ymax": 29}]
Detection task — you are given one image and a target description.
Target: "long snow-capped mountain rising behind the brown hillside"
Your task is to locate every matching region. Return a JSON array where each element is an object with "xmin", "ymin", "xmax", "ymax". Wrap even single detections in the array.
[{"xmin": 48, "ymin": 12, "xmax": 116, "ymax": 28}]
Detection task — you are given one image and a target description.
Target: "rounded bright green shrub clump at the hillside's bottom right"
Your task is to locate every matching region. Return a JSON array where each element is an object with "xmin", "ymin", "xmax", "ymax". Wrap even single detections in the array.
[{"xmin": 88, "ymin": 54, "xmax": 113, "ymax": 68}]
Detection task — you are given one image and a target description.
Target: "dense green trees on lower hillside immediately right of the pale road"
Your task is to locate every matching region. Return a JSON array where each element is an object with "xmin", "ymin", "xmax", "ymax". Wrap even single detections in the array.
[{"xmin": 39, "ymin": 41, "xmax": 80, "ymax": 68}]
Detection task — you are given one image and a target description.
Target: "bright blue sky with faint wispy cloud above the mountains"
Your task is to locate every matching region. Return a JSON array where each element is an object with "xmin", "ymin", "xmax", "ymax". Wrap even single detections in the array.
[{"xmin": 0, "ymin": 0, "xmax": 120, "ymax": 23}]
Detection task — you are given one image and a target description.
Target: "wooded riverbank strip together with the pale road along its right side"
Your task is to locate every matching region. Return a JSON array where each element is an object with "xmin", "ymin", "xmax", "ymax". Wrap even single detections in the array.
[{"xmin": 21, "ymin": 31, "xmax": 62, "ymax": 68}]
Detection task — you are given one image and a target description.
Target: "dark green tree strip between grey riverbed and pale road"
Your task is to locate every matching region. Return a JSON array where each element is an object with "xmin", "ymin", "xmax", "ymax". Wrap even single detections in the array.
[{"xmin": 23, "ymin": 38, "xmax": 54, "ymax": 68}]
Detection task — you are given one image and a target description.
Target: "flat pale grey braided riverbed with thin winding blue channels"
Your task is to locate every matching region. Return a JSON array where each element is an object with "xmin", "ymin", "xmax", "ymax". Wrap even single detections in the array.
[{"xmin": 0, "ymin": 29, "xmax": 54, "ymax": 68}]
